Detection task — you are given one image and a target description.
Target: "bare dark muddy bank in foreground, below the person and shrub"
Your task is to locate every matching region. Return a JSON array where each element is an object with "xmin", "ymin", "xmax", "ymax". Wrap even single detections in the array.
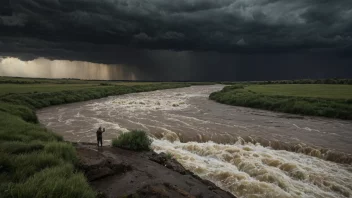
[{"xmin": 76, "ymin": 143, "xmax": 234, "ymax": 198}]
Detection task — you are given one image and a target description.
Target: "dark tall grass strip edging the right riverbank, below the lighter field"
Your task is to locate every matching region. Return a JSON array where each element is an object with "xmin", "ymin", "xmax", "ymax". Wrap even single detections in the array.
[{"xmin": 209, "ymin": 85, "xmax": 352, "ymax": 119}]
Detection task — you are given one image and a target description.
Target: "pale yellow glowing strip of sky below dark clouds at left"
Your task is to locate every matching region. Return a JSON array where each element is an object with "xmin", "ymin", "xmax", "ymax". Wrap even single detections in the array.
[{"xmin": 0, "ymin": 57, "xmax": 140, "ymax": 80}]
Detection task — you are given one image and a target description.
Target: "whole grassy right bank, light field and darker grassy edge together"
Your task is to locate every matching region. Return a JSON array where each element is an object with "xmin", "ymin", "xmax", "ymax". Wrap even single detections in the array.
[{"xmin": 209, "ymin": 84, "xmax": 352, "ymax": 119}]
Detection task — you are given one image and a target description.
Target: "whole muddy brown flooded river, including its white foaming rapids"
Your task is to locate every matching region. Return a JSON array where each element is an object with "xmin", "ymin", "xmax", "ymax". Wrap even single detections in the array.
[{"xmin": 37, "ymin": 85, "xmax": 352, "ymax": 197}]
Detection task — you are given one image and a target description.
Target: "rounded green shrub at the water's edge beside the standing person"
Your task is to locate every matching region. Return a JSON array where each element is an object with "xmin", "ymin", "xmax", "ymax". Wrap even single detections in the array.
[{"xmin": 112, "ymin": 130, "xmax": 152, "ymax": 151}]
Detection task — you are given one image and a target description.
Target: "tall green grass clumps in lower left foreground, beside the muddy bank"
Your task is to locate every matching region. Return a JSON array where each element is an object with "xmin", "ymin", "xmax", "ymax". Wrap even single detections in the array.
[{"xmin": 0, "ymin": 111, "xmax": 95, "ymax": 197}]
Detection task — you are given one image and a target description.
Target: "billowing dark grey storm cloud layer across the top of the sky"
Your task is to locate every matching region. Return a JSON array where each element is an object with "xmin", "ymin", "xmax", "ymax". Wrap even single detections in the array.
[{"xmin": 0, "ymin": 0, "xmax": 352, "ymax": 52}]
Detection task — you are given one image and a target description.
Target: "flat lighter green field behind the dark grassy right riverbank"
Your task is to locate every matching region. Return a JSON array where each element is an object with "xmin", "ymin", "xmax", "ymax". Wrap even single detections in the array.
[{"xmin": 245, "ymin": 84, "xmax": 352, "ymax": 99}]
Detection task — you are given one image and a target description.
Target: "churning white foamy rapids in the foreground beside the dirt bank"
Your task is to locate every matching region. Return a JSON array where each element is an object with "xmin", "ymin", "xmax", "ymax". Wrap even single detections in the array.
[{"xmin": 152, "ymin": 139, "xmax": 352, "ymax": 198}]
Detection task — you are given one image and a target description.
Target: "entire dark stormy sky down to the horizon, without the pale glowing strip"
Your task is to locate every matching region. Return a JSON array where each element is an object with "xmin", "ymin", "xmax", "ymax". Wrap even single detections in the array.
[{"xmin": 0, "ymin": 0, "xmax": 352, "ymax": 80}]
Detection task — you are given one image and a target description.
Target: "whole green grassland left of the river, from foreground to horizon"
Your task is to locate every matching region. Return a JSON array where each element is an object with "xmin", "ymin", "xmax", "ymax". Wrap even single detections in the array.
[{"xmin": 0, "ymin": 79, "xmax": 201, "ymax": 198}]
